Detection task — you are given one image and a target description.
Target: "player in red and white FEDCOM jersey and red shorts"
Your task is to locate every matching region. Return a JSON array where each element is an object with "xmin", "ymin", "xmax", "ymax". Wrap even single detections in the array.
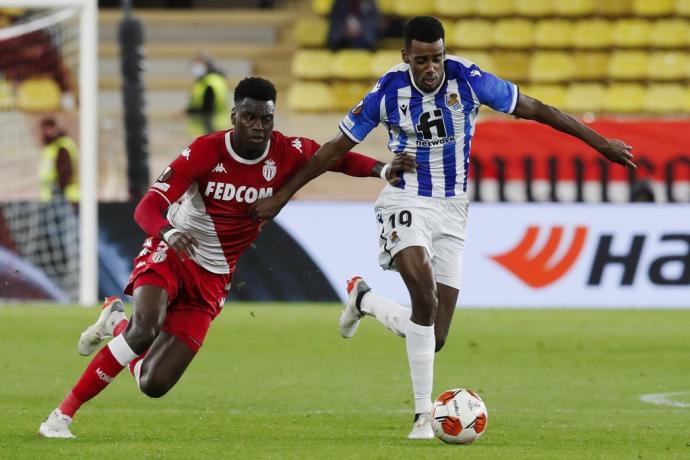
[{"xmin": 39, "ymin": 77, "xmax": 411, "ymax": 438}]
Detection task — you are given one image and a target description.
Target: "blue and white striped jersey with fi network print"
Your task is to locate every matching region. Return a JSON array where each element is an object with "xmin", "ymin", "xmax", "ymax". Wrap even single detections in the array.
[{"xmin": 340, "ymin": 56, "xmax": 518, "ymax": 197}]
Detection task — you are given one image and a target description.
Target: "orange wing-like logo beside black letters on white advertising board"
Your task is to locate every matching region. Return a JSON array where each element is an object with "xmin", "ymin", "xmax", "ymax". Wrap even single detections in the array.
[{"xmin": 491, "ymin": 226, "xmax": 587, "ymax": 288}]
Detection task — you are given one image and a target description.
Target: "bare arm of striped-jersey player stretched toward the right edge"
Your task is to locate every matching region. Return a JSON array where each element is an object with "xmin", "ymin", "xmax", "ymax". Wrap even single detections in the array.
[{"xmin": 513, "ymin": 94, "xmax": 637, "ymax": 169}]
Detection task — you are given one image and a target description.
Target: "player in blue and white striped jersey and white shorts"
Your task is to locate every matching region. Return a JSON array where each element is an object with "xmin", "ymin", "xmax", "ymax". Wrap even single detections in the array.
[{"xmin": 253, "ymin": 16, "xmax": 635, "ymax": 439}]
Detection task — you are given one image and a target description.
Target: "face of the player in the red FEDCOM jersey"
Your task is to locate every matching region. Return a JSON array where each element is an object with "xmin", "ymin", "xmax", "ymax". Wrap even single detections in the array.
[{"xmin": 232, "ymin": 97, "xmax": 275, "ymax": 156}]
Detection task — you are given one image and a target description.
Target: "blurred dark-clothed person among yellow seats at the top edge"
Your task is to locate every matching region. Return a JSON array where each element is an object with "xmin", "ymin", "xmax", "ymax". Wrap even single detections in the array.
[{"xmin": 328, "ymin": 0, "xmax": 379, "ymax": 51}]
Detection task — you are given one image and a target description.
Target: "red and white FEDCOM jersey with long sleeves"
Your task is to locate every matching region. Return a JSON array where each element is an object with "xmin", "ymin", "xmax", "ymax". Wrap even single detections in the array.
[{"xmin": 140, "ymin": 130, "xmax": 376, "ymax": 274}]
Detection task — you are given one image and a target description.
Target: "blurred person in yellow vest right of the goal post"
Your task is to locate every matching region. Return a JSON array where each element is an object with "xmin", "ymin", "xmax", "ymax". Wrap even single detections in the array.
[{"xmin": 187, "ymin": 54, "xmax": 230, "ymax": 136}]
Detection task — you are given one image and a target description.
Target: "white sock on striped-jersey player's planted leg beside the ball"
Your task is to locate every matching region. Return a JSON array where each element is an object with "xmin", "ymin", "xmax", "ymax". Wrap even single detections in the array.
[{"xmin": 405, "ymin": 321, "xmax": 436, "ymax": 414}]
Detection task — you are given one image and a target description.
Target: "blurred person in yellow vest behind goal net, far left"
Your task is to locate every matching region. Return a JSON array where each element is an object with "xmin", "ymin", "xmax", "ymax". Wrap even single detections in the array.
[{"xmin": 39, "ymin": 118, "xmax": 79, "ymax": 203}]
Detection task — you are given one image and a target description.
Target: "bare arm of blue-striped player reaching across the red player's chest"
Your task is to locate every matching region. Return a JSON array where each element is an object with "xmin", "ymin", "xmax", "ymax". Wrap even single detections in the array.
[{"xmin": 250, "ymin": 132, "xmax": 356, "ymax": 220}]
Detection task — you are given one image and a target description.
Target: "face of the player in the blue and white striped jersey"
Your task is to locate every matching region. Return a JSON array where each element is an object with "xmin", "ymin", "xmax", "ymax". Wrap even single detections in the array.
[{"xmin": 402, "ymin": 39, "xmax": 446, "ymax": 93}]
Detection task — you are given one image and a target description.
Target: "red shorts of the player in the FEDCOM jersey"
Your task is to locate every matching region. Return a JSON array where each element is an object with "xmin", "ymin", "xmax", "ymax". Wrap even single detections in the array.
[{"xmin": 125, "ymin": 237, "xmax": 232, "ymax": 352}]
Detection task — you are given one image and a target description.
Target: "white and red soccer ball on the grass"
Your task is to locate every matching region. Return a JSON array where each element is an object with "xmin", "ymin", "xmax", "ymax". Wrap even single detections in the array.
[{"xmin": 431, "ymin": 388, "xmax": 489, "ymax": 444}]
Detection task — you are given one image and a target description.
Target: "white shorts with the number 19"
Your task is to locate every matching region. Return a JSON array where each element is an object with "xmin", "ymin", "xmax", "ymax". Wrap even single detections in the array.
[{"xmin": 374, "ymin": 185, "xmax": 469, "ymax": 289}]
